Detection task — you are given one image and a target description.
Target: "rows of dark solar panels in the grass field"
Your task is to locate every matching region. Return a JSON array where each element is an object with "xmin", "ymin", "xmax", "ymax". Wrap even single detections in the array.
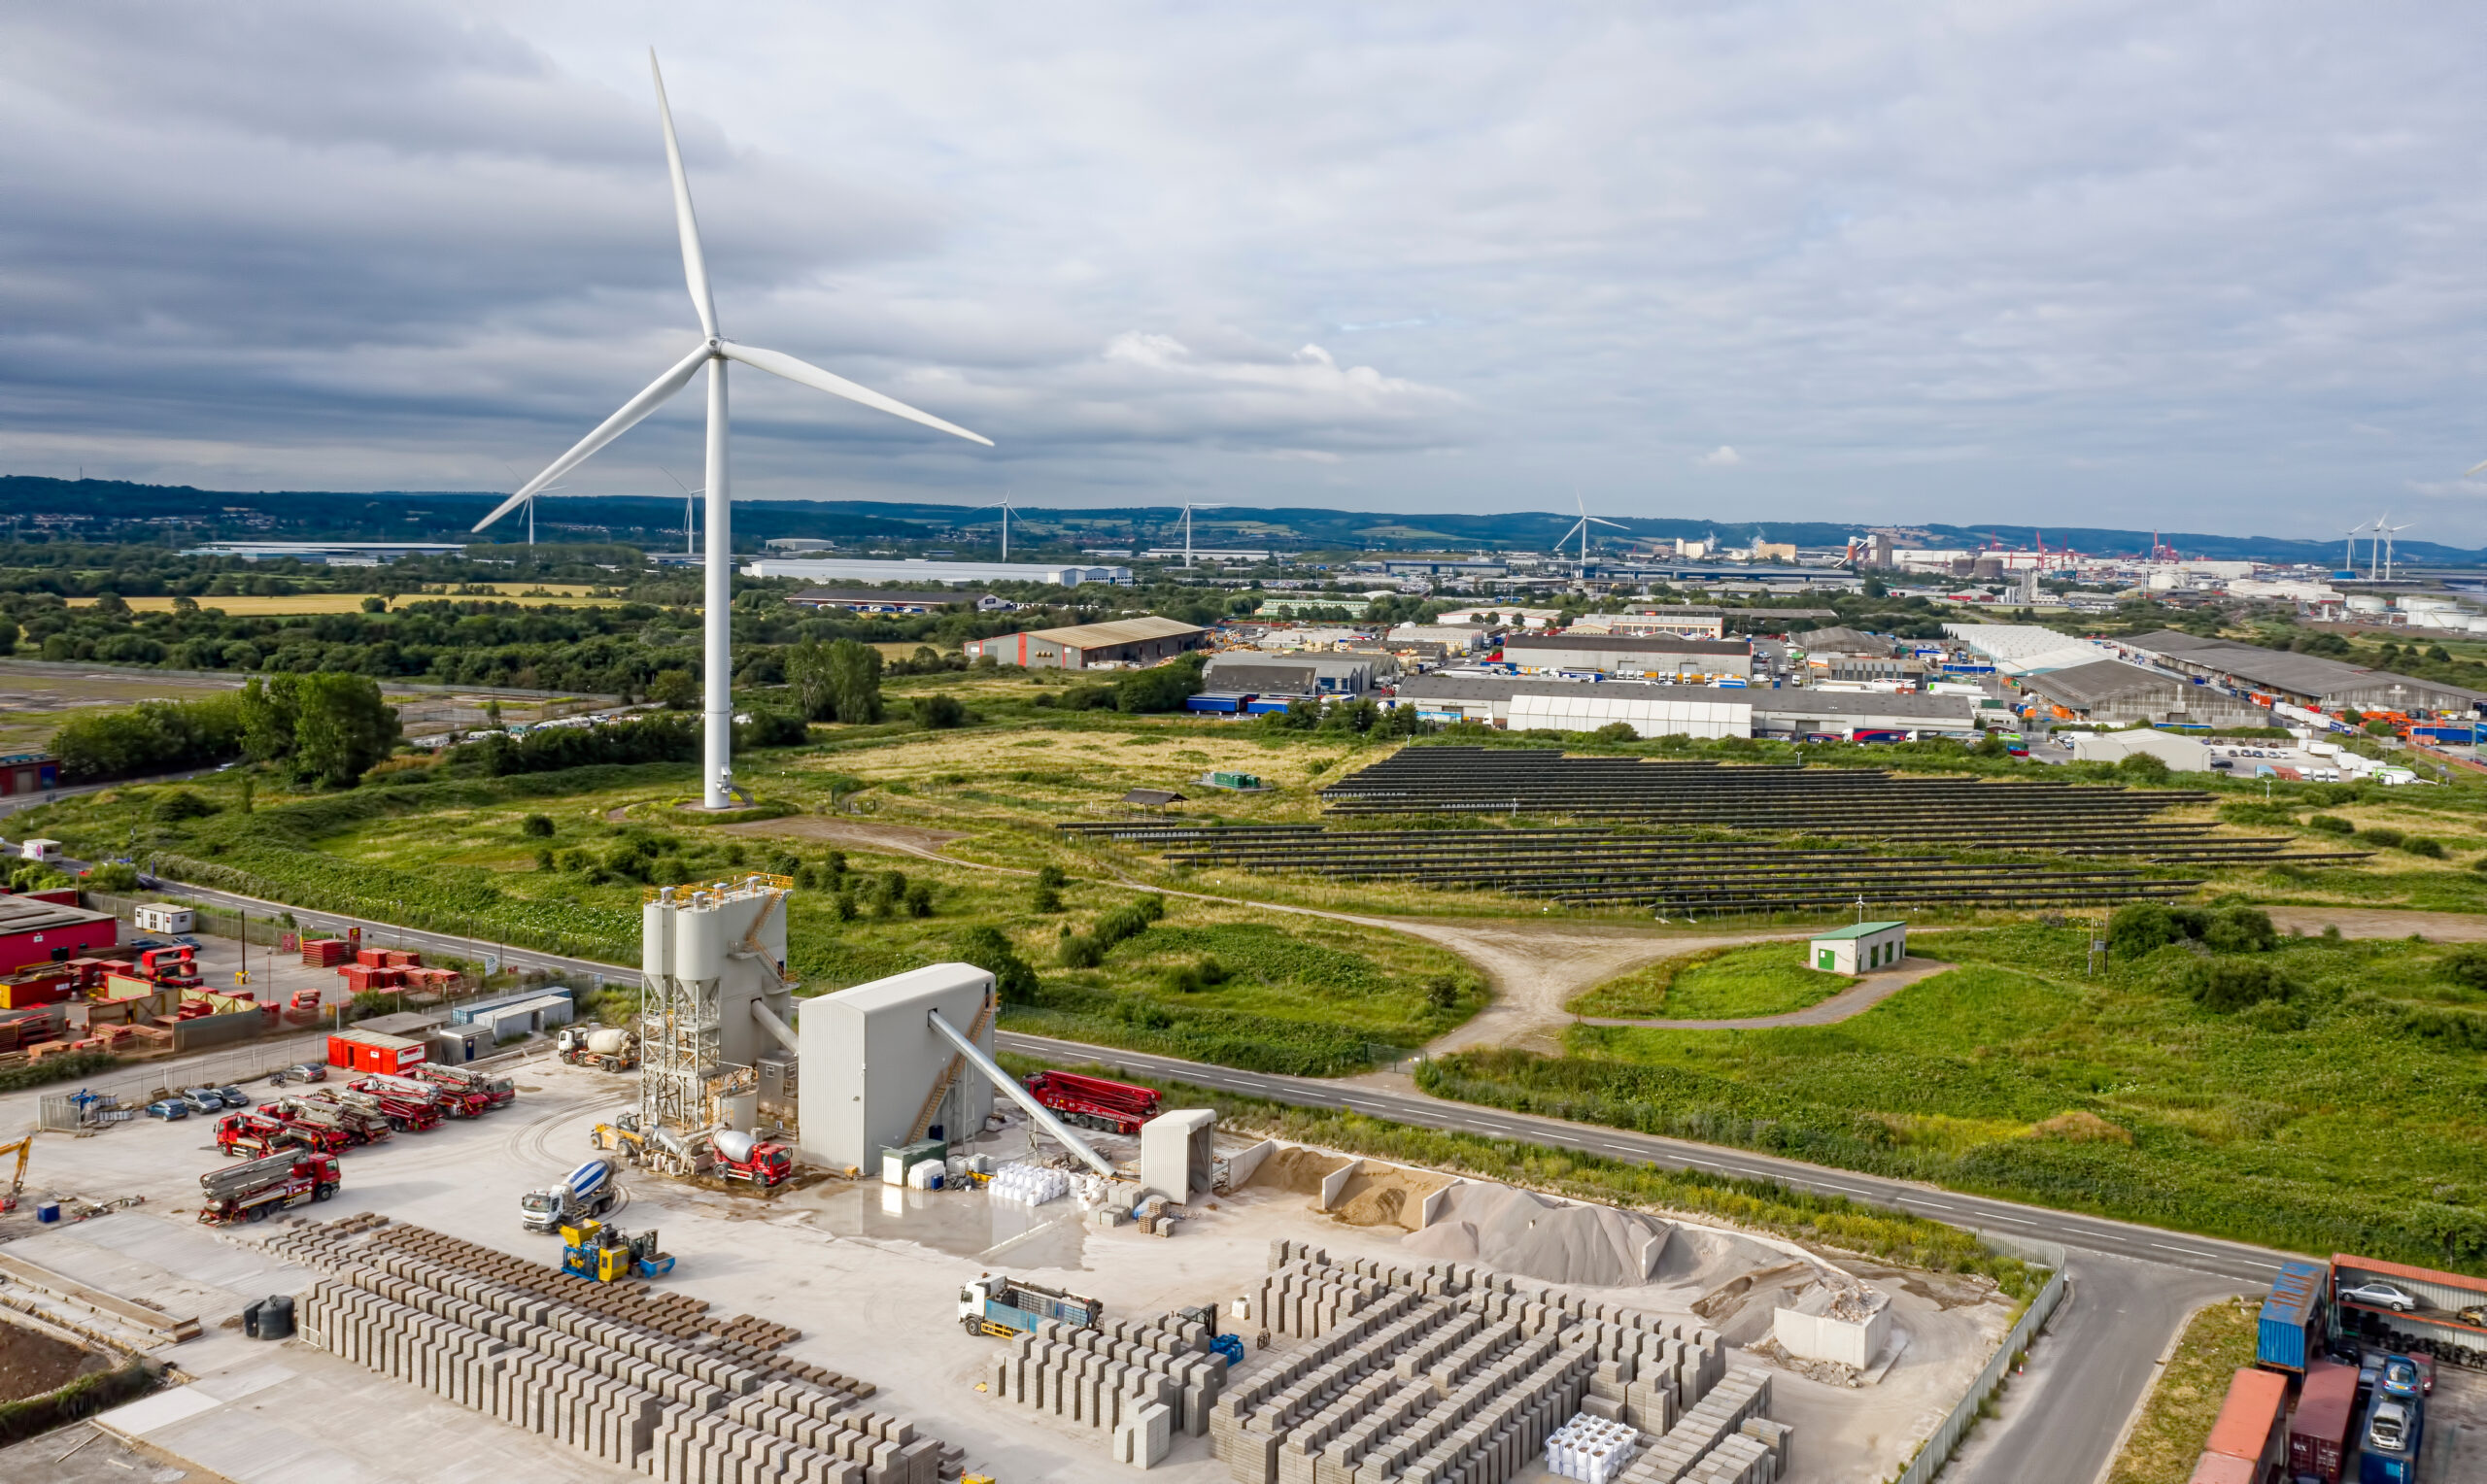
[{"xmin": 1065, "ymin": 748, "xmax": 2363, "ymax": 920}]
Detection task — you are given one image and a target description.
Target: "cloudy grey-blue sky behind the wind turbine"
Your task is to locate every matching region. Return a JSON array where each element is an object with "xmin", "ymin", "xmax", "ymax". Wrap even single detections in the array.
[{"xmin": 0, "ymin": 0, "xmax": 2487, "ymax": 545}]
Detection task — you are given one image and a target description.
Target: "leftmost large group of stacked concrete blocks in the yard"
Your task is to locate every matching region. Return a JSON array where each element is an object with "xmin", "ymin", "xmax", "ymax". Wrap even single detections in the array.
[{"xmin": 268, "ymin": 1226, "xmax": 960, "ymax": 1484}]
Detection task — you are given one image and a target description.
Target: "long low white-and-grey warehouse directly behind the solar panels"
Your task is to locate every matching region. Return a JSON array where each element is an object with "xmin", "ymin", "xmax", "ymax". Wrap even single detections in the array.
[{"xmin": 1393, "ymin": 676, "xmax": 1977, "ymax": 741}]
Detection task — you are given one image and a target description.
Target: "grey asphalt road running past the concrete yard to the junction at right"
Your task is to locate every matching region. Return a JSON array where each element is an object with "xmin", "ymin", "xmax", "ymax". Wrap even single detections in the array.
[{"xmin": 112, "ymin": 885, "xmax": 2286, "ymax": 1484}]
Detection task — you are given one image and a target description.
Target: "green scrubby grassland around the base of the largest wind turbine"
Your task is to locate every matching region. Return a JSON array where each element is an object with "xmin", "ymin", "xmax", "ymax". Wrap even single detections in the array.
[{"xmin": 19, "ymin": 733, "xmax": 1484, "ymax": 1076}]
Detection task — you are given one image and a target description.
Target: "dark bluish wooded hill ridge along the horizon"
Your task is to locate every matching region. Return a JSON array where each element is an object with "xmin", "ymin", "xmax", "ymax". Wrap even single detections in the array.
[{"xmin": 0, "ymin": 475, "xmax": 2487, "ymax": 567}]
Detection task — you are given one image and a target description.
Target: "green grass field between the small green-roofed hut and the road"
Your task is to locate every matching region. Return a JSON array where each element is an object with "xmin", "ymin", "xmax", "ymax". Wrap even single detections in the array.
[{"xmin": 1420, "ymin": 925, "xmax": 2487, "ymax": 1270}]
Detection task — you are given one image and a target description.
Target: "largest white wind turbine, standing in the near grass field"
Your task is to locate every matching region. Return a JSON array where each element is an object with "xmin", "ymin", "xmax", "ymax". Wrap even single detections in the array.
[{"xmin": 475, "ymin": 50, "xmax": 992, "ymax": 808}]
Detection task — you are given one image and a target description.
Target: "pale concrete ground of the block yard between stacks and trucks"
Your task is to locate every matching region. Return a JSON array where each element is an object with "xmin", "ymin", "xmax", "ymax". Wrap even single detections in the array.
[{"xmin": 0, "ymin": 1062, "xmax": 2007, "ymax": 1484}]
